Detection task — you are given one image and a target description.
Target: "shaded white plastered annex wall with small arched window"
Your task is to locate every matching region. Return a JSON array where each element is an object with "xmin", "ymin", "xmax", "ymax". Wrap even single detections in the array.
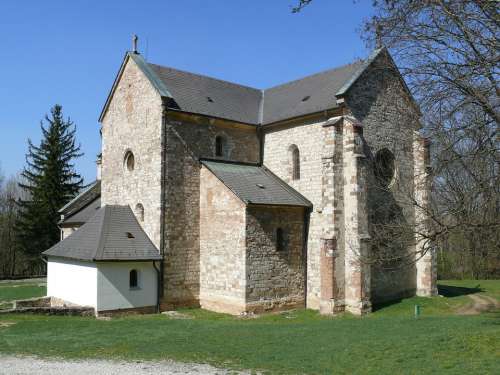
[{"xmin": 97, "ymin": 262, "xmax": 158, "ymax": 311}]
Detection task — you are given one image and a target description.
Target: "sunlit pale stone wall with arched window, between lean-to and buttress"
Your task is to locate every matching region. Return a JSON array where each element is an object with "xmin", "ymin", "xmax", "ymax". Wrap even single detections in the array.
[{"xmin": 264, "ymin": 120, "xmax": 325, "ymax": 309}]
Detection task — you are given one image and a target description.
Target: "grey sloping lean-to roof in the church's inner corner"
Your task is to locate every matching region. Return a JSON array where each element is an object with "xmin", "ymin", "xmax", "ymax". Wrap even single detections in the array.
[{"xmin": 201, "ymin": 160, "xmax": 312, "ymax": 207}]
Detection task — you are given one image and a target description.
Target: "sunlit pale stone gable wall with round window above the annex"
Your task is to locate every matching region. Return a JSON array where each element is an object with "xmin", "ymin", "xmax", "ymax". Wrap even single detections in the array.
[{"xmin": 101, "ymin": 59, "xmax": 162, "ymax": 248}]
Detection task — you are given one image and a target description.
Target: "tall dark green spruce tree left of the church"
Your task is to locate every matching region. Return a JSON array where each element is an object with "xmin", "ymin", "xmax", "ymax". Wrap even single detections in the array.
[{"xmin": 16, "ymin": 104, "xmax": 83, "ymax": 271}]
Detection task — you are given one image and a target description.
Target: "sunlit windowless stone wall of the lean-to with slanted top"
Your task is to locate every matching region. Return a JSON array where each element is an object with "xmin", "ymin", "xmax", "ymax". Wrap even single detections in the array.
[{"xmin": 200, "ymin": 167, "xmax": 246, "ymax": 314}]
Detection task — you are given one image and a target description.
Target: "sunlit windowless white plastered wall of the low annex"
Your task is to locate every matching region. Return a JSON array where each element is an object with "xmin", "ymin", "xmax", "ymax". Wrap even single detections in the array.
[{"xmin": 47, "ymin": 258, "xmax": 97, "ymax": 308}]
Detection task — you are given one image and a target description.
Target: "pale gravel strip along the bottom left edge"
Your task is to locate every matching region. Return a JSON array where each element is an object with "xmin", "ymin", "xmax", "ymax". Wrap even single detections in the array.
[{"xmin": 0, "ymin": 356, "xmax": 250, "ymax": 375}]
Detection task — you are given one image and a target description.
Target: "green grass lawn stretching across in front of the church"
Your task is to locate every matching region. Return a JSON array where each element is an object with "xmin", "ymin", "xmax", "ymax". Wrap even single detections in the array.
[{"xmin": 0, "ymin": 280, "xmax": 500, "ymax": 374}]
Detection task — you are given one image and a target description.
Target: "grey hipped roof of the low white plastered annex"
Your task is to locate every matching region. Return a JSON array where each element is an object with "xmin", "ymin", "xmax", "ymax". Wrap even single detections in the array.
[{"xmin": 43, "ymin": 206, "xmax": 161, "ymax": 261}]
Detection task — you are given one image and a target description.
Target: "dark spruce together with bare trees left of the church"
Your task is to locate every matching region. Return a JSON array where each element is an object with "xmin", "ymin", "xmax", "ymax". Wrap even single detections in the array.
[{"xmin": 0, "ymin": 105, "xmax": 83, "ymax": 278}]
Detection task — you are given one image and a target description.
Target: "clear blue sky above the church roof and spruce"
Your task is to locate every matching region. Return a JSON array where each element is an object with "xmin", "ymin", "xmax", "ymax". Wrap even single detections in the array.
[{"xmin": 0, "ymin": 0, "xmax": 372, "ymax": 182}]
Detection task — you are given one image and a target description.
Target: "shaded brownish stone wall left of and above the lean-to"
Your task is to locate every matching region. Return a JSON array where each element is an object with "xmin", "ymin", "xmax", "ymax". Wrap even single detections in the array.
[{"xmin": 163, "ymin": 113, "xmax": 259, "ymax": 308}]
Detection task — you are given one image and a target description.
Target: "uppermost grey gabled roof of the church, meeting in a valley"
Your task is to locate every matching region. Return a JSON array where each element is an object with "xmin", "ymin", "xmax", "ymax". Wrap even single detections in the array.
[{"xmin": 99, "ymin": 48, "xmax": 387, "ymax": 125}]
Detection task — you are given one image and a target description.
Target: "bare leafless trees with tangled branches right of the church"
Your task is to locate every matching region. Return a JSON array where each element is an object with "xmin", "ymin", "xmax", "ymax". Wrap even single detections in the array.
[{"xmin": 292, "ymin": 0, "xmax": 500, "ymax": 279}]
